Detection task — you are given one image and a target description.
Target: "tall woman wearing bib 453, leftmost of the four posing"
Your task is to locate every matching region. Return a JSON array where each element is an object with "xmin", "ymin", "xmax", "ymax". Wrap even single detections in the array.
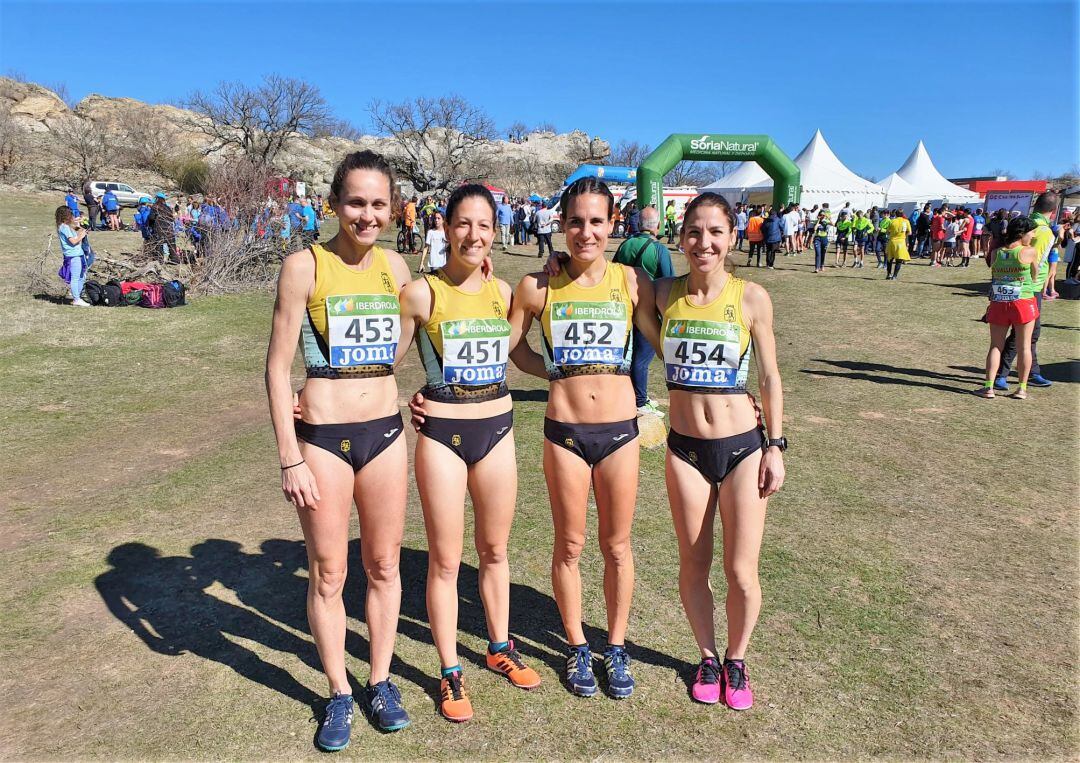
[{"xmin": 266, "ymin": 151, "xmax": 409, "ymax": 750}]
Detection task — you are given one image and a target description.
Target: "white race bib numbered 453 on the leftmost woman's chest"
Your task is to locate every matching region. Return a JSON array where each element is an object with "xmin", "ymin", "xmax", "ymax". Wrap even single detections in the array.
[{"xmin": 326, "ymin": 294, "xmax": 402, "ymax": 369}]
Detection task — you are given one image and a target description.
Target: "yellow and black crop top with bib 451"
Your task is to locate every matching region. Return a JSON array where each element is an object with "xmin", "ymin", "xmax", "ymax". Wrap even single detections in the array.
[{"xmin": 417, "ymin": 270, "xmax": 510, "ymax": 403}]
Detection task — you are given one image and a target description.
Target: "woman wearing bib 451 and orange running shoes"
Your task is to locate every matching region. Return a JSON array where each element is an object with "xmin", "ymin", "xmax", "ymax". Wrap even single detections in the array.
[{"xmin": 399, "ymin": 185, "xmax": 540, "ymax": 722}]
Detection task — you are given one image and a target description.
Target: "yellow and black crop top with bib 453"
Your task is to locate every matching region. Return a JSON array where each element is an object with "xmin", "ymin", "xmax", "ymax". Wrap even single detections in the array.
[{"xmin": 300, "ymin": 244, "xmax": 401, "ymax": 379}]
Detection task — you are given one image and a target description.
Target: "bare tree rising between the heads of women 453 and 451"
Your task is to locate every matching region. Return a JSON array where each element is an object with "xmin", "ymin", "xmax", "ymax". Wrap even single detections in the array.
[{"xmin": 368, "ymin": 95, "xmax": 495, "ymax": 191}]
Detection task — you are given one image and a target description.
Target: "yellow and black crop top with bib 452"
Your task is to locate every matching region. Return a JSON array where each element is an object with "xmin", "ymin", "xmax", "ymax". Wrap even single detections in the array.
[{"xmin": 540, "ymin": 263, "xmax": 634, "ymax": 379}]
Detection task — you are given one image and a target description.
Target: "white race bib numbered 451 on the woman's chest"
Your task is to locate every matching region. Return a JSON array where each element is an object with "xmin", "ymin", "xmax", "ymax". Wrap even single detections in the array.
[{"xmin": 438, "ymin": 318, "xmax": 510, "ymax": 386}]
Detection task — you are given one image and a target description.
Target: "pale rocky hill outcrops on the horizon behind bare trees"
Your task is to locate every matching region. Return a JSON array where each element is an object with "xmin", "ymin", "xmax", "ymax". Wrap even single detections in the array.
[{"xmin": 0, "ymin": 78, "xmax": 610, "ymax": 193}]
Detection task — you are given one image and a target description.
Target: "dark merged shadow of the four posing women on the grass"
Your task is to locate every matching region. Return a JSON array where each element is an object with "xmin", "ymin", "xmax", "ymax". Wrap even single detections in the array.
[{"xmin": 95, "ymin": 538, "xmax": 694, "ymax": 717}]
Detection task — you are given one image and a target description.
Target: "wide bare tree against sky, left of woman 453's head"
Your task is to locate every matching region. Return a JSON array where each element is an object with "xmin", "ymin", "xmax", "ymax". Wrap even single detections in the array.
[{"xmin": 185, "ymin": 75, "xmax": 330, "ymax": 165}]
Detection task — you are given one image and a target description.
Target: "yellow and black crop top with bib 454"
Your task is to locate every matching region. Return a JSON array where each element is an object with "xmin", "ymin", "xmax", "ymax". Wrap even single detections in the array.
[{"xmin": 660, "ymin": 276, "xmax": 753, "ymax": 394}]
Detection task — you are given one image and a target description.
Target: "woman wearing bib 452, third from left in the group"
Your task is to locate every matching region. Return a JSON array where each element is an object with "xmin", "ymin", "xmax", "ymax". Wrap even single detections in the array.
[{"xmin": 510, "ymin": 177, "xmax": 659, "ymax": 698}]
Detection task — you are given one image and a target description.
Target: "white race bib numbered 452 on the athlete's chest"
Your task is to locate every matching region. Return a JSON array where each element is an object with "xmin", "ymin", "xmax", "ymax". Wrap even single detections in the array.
[{"xmin": 551, "ymin": 302, "xmax": 627, "ymax": 365}]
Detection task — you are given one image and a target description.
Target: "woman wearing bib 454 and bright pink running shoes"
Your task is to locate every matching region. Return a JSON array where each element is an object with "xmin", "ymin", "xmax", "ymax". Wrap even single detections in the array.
[{"xmin": 654, "ymin": 192, "xmax": 787, "ymax": 710}]
